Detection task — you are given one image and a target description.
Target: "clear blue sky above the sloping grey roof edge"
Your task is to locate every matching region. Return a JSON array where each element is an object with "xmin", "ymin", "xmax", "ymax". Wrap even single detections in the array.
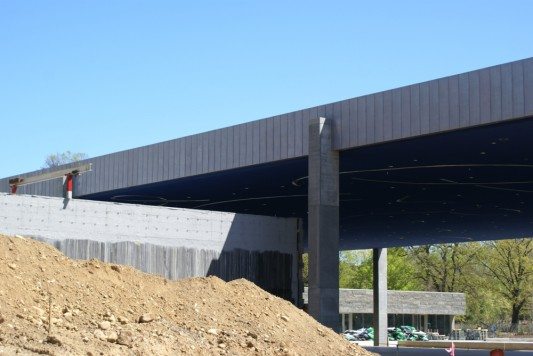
[{"xmin": 0, "ymin": 0, "xmax": 533, "ymax": 177}]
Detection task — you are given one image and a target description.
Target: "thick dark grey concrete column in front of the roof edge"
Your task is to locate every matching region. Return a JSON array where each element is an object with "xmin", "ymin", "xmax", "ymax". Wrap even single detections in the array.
[{"xmin": 308, "ymin": 117, "xmax": 340, "ymax": 331}]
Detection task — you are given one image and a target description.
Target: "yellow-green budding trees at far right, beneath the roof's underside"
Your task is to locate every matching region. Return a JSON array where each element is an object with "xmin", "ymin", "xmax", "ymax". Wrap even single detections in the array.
[{"xmin": 409, "ymin": 239, "xmax": 533, "ymax": 326}]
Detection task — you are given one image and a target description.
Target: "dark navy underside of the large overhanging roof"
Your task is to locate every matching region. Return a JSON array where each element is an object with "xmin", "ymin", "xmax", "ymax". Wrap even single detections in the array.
[{"xmin": 80, "ymin": 118, "xmax": 533, "ymax": 249}]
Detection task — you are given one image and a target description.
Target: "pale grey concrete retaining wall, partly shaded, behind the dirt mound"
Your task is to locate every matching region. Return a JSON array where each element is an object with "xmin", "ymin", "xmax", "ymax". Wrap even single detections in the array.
[{"xmin": 0, "ymin": 194, "xmax": 298, "ymax": 300}]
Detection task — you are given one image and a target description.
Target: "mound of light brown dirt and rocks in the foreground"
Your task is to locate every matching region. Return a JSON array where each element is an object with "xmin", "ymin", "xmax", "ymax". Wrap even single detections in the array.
[{"xmin": 0, "ymin": 236, "xmax": 370, "ymax": 355}]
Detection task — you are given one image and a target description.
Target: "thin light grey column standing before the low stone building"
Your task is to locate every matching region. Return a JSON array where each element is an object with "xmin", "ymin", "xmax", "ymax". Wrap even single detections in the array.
[{"xmin": 372, "ymin": 248, "xmax": 389, "ymax": 346}]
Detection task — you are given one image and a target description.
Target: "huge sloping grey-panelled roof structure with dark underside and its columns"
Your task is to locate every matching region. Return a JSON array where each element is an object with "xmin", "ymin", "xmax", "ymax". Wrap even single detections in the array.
[{"xmin": 0, "ymin": 58, "xmax": 533, "ymax": 340}]
